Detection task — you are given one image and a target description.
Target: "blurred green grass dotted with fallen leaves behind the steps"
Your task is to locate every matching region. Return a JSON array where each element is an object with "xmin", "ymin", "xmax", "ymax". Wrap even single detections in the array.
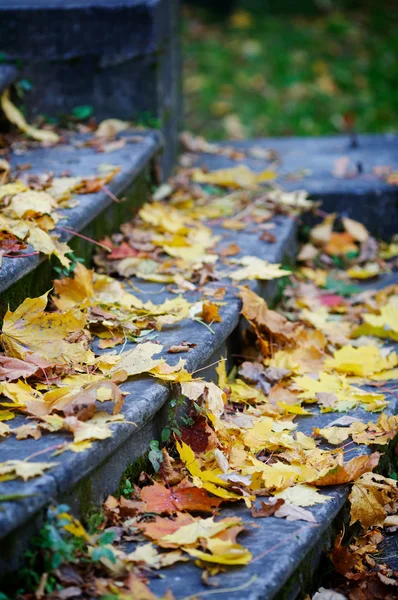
[{"xmin": 183, "ymin": 0, "xmax": 398, "ymax": 139}]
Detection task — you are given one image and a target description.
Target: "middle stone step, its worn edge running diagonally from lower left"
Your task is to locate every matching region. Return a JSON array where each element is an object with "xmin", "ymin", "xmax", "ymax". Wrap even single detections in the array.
[{"xmin": 0, "ymin": 204, "xmax": 296, "ymax": 576}]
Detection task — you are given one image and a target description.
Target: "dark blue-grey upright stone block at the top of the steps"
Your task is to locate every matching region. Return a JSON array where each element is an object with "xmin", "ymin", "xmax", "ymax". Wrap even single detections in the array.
[{"xmin": 0, "ymin": 0, "xmax": 182, "ymax": 175}]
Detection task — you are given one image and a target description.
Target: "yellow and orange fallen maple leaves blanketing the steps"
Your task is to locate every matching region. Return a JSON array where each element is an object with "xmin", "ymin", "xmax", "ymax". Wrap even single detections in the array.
[{"xmin": 0, "ymin": 157, "xmax": 398, "ymax": 599}]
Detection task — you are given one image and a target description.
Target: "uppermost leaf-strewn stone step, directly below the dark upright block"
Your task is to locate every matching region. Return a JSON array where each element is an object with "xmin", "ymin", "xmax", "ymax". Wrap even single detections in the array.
[{"xmin": 0, "ymin": 126, "xmax": 162, "ymax": 316}]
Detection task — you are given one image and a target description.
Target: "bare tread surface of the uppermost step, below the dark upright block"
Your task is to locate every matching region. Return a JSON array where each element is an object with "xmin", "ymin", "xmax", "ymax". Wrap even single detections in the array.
[{"xmin": 0, "ymin": 131, "xmax": 161, "ymax": 293}]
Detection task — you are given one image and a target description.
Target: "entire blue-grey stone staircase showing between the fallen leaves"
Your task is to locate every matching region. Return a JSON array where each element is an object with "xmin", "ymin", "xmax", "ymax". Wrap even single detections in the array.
[{"xmin": 0, "ymin": 0, "xmax": 398, "ymax": 600}]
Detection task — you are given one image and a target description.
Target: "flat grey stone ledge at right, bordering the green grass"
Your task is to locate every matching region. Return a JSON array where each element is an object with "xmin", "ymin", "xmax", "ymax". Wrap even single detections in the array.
[{"xmin": 188, "ymin": 133, "xmax": 398, "ymax": 239}]
